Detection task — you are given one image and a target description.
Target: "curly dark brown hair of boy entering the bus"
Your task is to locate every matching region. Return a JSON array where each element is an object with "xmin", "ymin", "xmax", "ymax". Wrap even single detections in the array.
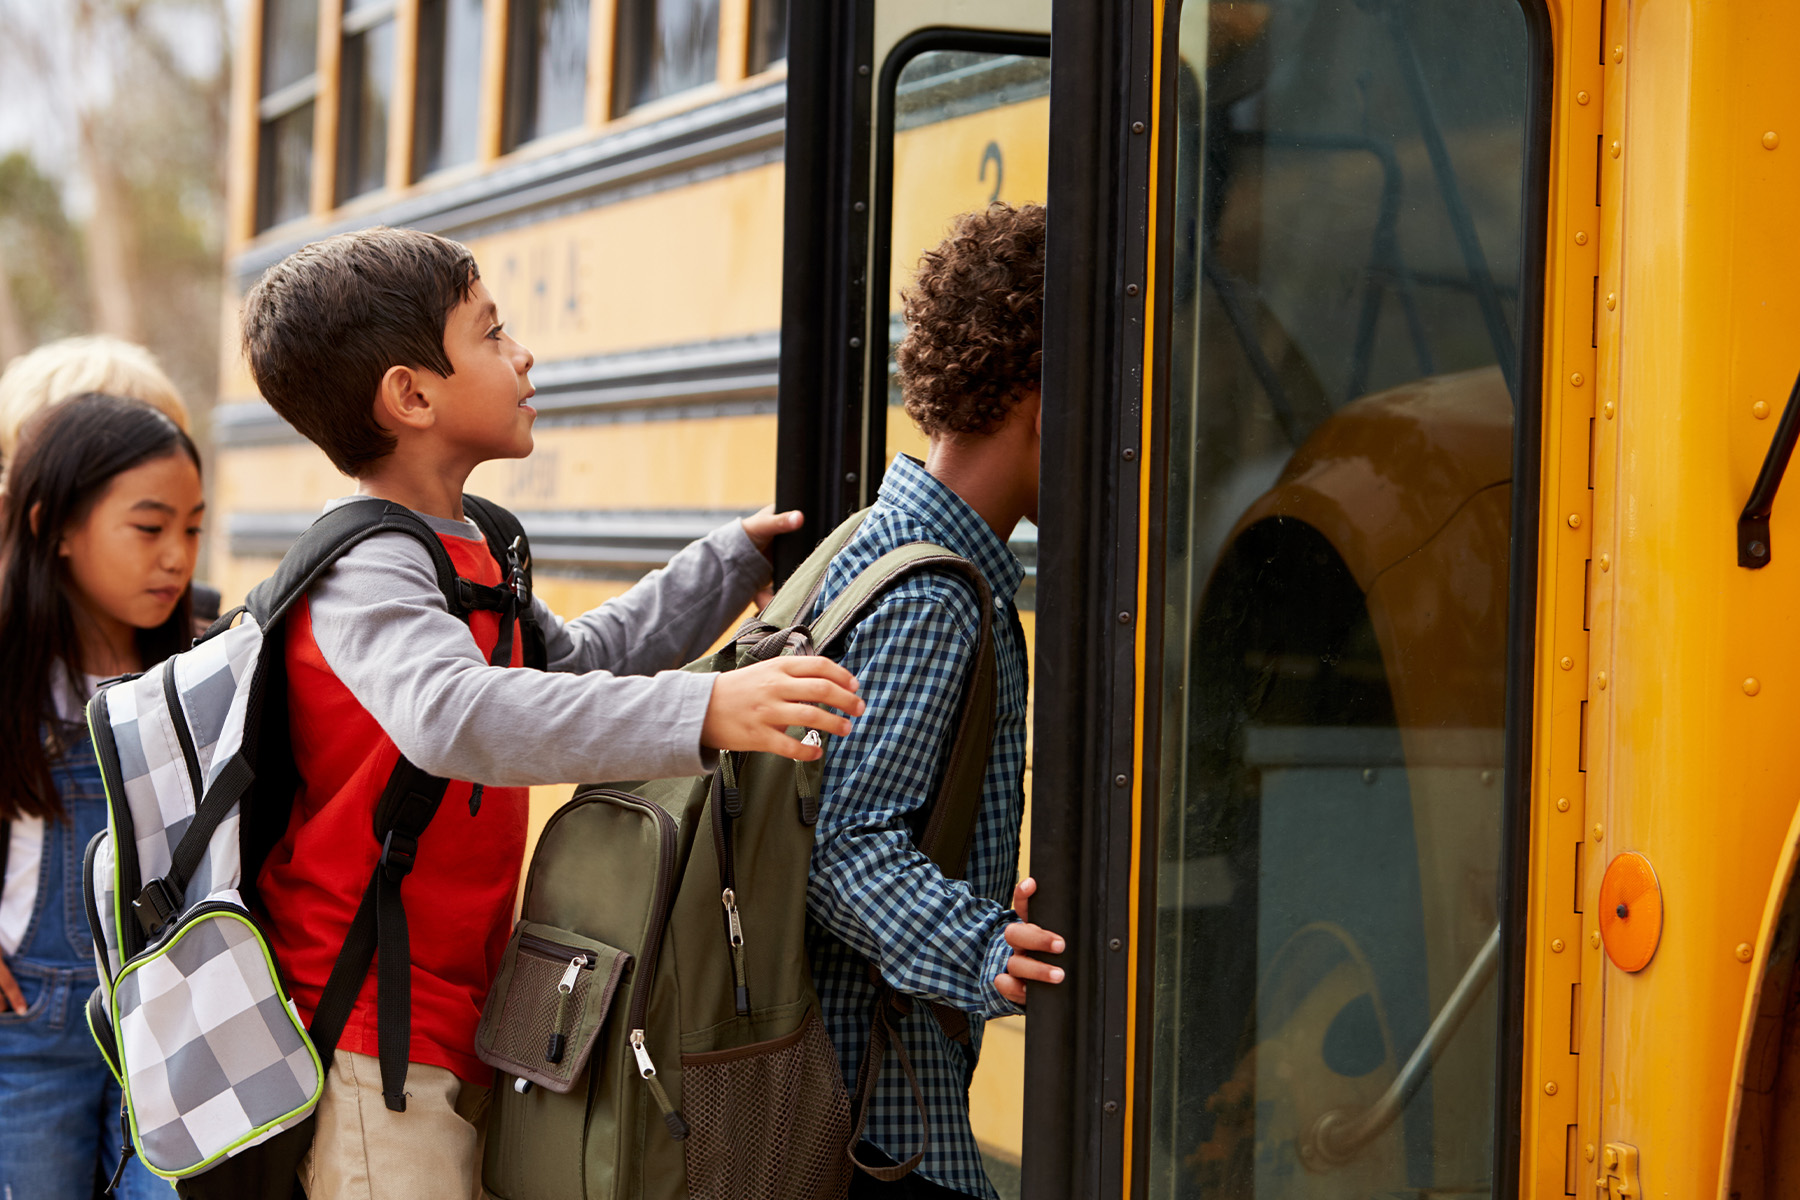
[{"xmin": 895, "ymin": 201, "xmax": 1044, "ymax": 434}]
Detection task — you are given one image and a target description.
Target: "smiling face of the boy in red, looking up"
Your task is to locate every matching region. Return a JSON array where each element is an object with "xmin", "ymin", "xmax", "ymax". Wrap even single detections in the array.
[{"xmin": 418, "ymin": 279, "xmax": 538, "ymax": 462}]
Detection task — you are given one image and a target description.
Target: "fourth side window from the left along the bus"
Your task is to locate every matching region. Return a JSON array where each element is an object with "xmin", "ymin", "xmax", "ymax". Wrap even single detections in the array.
[{"xmin": 504, "ymin": 0, "xmax": 589, "ymax": 151}]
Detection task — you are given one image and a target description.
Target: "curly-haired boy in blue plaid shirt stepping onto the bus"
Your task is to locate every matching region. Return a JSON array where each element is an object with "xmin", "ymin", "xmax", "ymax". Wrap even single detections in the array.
[{"xmin": 808, "ymin": 203, "xmax": 1064, "ymax": 1198}]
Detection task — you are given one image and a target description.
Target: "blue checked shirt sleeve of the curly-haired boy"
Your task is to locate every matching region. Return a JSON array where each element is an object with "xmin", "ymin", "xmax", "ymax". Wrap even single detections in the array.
[{"xmin": 806, "ymin": 585, "xmax": 1019, "ymax": 1016}]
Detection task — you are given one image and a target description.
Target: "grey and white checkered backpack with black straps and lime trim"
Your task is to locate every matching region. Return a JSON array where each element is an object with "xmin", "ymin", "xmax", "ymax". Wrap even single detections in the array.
[{"xmin": 83, "ymin": 497, "xmax": 545, "ymax": 1200}]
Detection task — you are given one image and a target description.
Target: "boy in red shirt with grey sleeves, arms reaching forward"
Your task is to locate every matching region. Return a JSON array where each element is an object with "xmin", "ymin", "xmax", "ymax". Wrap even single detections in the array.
[{"xmin": 243, "ymin": 228, "xmax": 862, "ymax": 1200}]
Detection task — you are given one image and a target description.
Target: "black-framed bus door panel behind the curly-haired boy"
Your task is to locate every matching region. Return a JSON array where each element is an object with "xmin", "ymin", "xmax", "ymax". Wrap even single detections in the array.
[{"xmin": 776, "ymin": 0, "xmax": 1049, "ymax": 1198}]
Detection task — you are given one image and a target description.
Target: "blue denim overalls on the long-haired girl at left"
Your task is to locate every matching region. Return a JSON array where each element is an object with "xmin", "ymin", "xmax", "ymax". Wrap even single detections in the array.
[{"xmin": 0, "ymin": 741, "xmax": 175, "ymax": 1200}]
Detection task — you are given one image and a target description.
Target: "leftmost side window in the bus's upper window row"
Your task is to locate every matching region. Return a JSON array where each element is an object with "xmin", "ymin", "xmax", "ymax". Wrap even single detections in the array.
[{"xmin": 256, "ymin": 0, "xmax": 319, "ymax": 230}]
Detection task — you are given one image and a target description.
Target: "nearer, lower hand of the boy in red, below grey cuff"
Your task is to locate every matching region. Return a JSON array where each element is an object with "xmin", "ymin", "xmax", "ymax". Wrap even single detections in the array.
[{"xmin": 700, "ymin": 655, "xmax": 866, "ymax": 763}]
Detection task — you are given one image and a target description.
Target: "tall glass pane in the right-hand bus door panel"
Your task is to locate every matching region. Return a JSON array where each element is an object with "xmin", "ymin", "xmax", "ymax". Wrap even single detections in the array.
[{"xmin": 1148, "ymin": 0, "xmax": 1528, "ymax": 1200}]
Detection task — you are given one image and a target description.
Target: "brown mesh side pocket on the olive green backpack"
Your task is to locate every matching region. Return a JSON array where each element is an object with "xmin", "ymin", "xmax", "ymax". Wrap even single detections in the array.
[{"xmin": 680, "ymin": 1009, "xmax": 850, "ymax": 1200}]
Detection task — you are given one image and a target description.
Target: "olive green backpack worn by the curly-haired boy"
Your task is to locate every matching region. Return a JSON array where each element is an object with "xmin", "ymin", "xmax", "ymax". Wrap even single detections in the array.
[{"xmin": 475, "ymin": 513, "xmax": 994, "ymax": 1200}]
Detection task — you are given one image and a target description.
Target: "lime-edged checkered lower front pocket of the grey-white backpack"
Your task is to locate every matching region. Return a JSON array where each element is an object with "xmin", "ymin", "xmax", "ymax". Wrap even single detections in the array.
[{"xmin": 113, "ymin": 905, "xmax": 322, "ymax": 1175}]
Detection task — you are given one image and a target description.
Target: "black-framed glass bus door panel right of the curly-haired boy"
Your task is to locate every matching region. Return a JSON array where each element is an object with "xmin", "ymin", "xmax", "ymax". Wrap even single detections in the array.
[{"xmin": 1024, "ymin": 0, "xmax": 1548, "ymax": 1200}]
